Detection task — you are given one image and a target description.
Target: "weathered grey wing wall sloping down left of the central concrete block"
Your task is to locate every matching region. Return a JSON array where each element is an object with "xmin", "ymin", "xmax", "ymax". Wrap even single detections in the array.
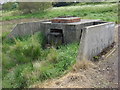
[{"xmin": 8, "ymin": 21, "xmax": 42, "ymax": 38}]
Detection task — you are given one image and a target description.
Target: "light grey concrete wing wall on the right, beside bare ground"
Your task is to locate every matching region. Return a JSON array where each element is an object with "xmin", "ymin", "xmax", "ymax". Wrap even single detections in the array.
[{"xmin": 77, "ymin": 22, "xmax": 115, "ymax": 60}]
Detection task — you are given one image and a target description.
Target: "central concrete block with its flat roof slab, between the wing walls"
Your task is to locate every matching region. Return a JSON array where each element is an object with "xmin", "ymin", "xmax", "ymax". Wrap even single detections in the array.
[{"xmin": 41, "ymin": 19, "xmax": 101, "ymax": 44}]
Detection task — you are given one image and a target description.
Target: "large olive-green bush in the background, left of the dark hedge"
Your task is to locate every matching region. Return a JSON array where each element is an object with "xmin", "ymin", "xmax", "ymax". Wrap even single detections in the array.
[{"xmin": 19, "ymin": 2, "xmax": 52, "ymax": 14}]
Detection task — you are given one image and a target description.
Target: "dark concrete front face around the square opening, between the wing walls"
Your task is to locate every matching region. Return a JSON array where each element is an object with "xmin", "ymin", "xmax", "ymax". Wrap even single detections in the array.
[{"xmin": 41, "ymin": 23, "xmax": 81, "ymax": 44}]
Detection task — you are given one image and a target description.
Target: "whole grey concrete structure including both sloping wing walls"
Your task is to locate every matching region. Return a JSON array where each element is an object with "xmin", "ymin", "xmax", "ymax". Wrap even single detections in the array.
[{"xmin": 8, "ymin": 20, "xmax": 115, "ymax": 60}]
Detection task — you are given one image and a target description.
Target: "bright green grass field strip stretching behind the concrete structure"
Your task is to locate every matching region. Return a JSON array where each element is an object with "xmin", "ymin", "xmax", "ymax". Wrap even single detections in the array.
[{"xmin": 2, "ymin": 3, "xmax": 118, "ymax": 23}]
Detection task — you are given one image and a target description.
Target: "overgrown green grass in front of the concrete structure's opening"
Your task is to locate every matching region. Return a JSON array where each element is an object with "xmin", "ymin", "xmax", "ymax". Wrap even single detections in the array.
[{"xmin": 2, "ymin": 33, "xmax": 79, "ymax": 88}]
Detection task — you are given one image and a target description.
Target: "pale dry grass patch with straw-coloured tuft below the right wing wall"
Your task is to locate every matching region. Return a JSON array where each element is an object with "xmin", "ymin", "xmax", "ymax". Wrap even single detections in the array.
[{"xmin": 31, "ymin": 60, "xmax": 109, "ymax": 88}]
